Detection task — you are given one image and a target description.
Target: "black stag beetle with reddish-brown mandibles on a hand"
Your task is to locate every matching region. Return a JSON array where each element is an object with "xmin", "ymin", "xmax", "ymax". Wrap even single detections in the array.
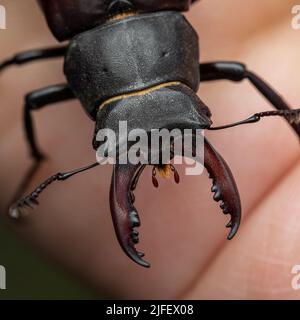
[{"xmin": 0, "ymin": 0, "xmax": 300, "ymax": 267}]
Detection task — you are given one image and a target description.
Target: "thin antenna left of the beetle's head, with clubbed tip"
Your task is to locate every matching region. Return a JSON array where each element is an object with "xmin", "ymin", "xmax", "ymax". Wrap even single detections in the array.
[{"xmin": 9, "ymin": 162, "xmax": 99, "ymax": 219}]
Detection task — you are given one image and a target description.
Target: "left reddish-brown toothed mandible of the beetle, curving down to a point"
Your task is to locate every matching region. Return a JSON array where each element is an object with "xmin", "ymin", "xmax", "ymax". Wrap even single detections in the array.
[{"xmin": 110, "ymin": 164, "xmax": 150, "ymax": 267}]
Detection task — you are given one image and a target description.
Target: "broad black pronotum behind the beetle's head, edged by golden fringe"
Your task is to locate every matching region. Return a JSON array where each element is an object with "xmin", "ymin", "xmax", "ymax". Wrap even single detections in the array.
[{"xmin": 65, "ymin": 11, "xmax": 199, "ymax": 117}]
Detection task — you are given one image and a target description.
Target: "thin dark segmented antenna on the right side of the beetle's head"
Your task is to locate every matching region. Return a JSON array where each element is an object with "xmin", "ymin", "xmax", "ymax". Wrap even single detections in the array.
[{"xmin": 207, "ymin": 109, "xmax": 300, "ymax": 130}]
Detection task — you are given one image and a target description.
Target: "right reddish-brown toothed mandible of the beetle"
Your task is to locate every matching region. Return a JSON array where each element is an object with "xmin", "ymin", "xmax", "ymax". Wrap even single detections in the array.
[{"xmin": 204, "ymin": 139, "xmax": 241, "ymax": 240}]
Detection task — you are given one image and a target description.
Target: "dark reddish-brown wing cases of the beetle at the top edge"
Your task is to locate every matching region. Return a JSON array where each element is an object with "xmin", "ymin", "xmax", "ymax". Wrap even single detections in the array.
[{"xmin": 38, "ymin": 0, "xmax": 202, "ymax": 41}]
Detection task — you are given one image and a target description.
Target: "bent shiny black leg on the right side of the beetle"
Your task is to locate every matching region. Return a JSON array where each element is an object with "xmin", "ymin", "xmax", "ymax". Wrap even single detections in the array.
[{"xmin": 200, "ymin": 61, "xmax": 300, "ymax": 137}]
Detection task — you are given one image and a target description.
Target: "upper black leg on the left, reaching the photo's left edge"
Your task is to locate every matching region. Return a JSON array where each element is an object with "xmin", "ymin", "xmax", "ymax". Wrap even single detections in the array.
[{"xmin": 0, "ymin": 46, "xmax": 67, "ymax": 72}]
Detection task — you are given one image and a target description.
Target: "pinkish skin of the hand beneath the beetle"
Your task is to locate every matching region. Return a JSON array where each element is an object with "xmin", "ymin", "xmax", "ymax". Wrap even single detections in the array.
[{"xmin": 0, "ymin": 0, "xmax": 300, "ymax": 299}]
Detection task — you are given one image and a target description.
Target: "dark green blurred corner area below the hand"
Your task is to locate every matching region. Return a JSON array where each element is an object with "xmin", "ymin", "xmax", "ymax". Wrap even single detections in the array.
[{"xmin": 0, "ymin": 218, "xmax": 96, "ymax": 300}]
